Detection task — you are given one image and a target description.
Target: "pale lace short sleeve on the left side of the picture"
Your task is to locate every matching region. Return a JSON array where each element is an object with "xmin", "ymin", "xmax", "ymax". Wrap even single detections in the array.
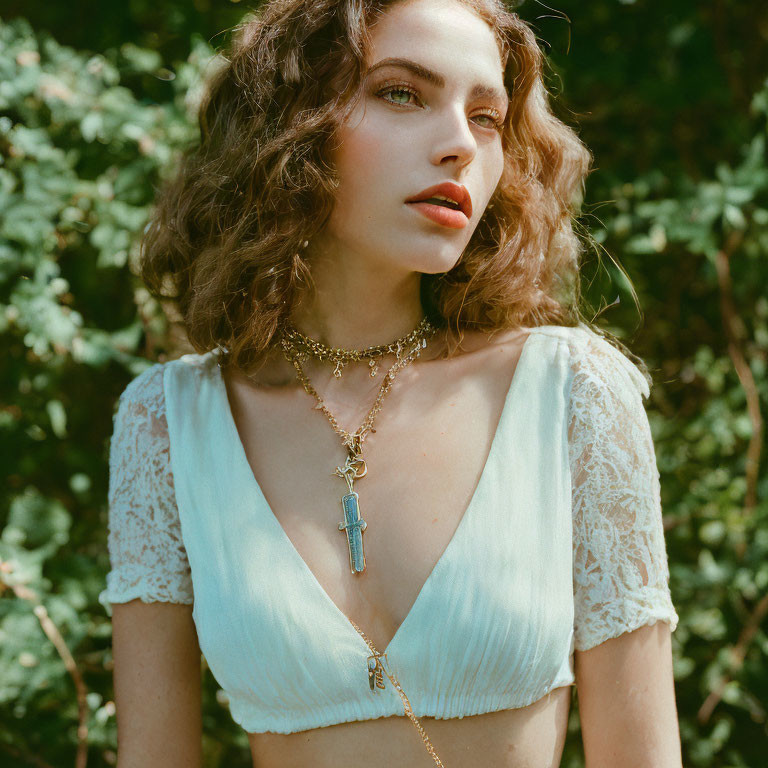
[{"xmin": 99, "ymin": 363, "xmax": 193, "ymax": 616}]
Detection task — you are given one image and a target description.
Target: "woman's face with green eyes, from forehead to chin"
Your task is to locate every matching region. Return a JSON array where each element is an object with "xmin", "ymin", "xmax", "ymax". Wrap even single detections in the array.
[{"xmin": 323, "ymin": 0, "xmax": 508, "ymax": 274}]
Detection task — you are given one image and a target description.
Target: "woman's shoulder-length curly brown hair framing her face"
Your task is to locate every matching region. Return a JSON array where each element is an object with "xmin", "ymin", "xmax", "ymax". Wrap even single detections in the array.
[{"xmin": 140, "ymin": 0, "xmax": 650, "ymax": 388}]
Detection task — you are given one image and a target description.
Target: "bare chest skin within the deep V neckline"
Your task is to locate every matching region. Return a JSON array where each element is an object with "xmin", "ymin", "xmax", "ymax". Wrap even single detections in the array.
[{"xmin": 220, "ymin": 332, "xmax": 522, "ymax": 648}]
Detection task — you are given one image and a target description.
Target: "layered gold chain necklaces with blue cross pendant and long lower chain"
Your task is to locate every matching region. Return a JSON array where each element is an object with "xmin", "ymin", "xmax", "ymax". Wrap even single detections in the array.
[{"xmin": 280, "ymin": 318, "xmax": 445, "ymax": 768}]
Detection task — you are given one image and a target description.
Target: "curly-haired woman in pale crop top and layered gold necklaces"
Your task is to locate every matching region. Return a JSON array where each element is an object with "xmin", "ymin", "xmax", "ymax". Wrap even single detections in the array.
[{"xmin": 103, "ymin": 0, "xmax": 681, "ymax": 768}]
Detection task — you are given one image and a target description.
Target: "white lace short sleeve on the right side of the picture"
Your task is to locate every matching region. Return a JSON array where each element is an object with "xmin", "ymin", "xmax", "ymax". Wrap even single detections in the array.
[{"xmin": 568, "ymin": 330, "xmax": 678, "ymax": 651}]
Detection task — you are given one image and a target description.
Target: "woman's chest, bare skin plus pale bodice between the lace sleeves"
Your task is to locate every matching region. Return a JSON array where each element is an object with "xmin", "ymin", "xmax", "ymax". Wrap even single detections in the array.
[{"xmin": 165, "ymin": 333, "xmax": 573, "ymax": 733}]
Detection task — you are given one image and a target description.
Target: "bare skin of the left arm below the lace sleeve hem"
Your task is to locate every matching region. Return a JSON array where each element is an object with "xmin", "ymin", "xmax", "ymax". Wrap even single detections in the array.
[{"xmin": 112, "ymin": 599, "xmax": 202, "ymax": 768}]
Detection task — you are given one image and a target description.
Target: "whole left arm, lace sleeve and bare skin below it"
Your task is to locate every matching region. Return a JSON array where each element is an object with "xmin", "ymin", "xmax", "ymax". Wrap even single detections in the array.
[{"xmin": 99, "ymin": 366, "xmax": 202, "ymax": 768}]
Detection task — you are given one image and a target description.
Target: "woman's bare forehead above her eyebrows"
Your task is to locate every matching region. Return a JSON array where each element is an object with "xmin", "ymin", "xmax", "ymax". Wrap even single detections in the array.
[{"xmin": 366, "ymin": 0, "xmax": 503, "ymax": 86}]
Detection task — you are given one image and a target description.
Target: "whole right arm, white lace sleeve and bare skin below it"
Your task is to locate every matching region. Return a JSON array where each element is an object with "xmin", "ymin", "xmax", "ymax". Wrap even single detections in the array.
[{"xmin": 569, "ymin": 332, "xmax": 681, "ymax": 768}]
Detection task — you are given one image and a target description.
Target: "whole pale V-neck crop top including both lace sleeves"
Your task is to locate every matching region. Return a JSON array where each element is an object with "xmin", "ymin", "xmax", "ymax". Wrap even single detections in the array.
[{"xmin": 99, "ymin": 325, "xmax": 678, "ymax": 733}]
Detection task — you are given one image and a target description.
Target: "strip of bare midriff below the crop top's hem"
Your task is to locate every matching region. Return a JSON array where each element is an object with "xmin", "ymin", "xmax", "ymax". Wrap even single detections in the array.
[{"xmin": 248, "ymin": 686, "xmax": 573, "ymax": 768}]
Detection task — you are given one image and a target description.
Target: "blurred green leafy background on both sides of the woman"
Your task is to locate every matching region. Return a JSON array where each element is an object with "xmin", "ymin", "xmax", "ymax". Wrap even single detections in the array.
[{"xmin": 0, "ymin": 0, "xmax": 768, "ymax": 768}]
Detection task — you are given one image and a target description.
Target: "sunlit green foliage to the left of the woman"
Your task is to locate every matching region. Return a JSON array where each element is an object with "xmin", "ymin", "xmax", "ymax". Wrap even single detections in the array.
[{"xmin": 0, "ymin": 13, "xmax": 249, "ymax": 765}]
